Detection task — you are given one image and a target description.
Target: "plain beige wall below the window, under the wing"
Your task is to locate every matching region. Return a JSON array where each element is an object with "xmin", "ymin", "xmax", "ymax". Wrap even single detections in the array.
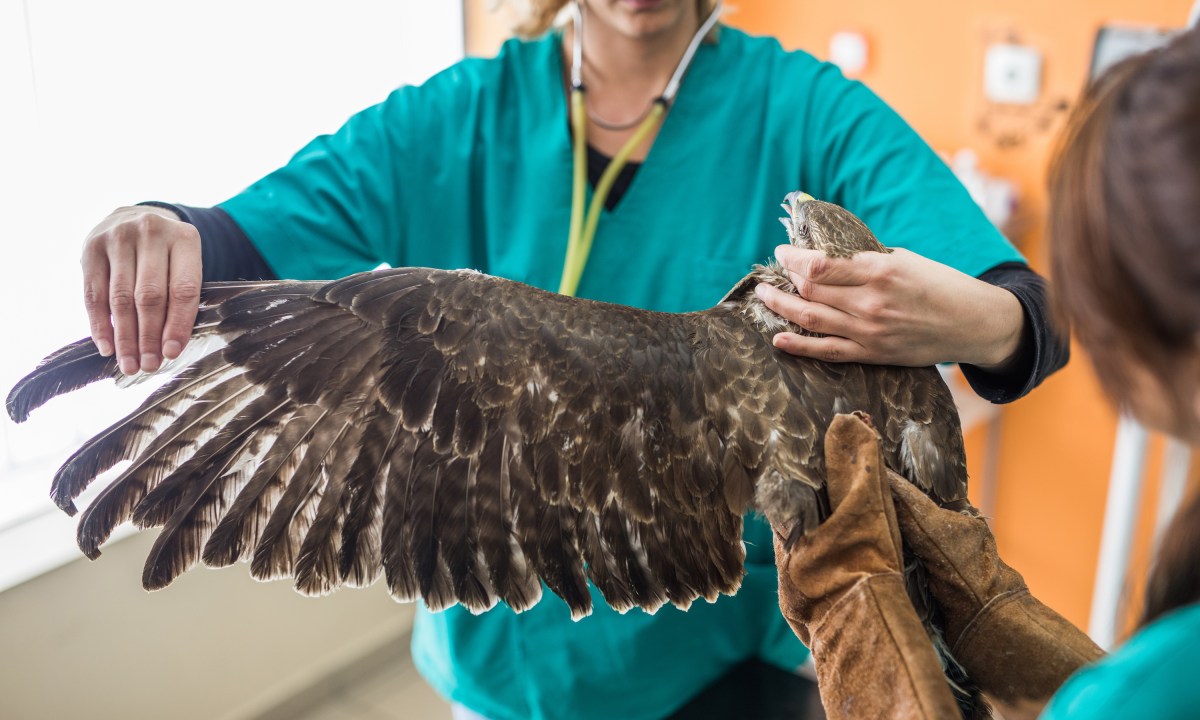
[{"xmin": 0, "ymin": 534, "xmax": 413, "ymax": 720}]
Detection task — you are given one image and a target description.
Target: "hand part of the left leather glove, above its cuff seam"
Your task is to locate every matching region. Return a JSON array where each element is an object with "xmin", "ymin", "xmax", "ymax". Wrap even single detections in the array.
[{"xmin": 774, "ymin": 413, "xmax": 904, "ymax": 647}]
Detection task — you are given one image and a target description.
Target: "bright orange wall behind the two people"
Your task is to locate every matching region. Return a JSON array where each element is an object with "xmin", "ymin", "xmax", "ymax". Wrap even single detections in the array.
[{"xmin": 466, "ymin": 0, "xmax": 1200, "ymax": 625}]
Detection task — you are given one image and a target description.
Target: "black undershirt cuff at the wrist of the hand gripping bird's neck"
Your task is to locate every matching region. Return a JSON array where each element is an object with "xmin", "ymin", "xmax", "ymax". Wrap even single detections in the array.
[{"xmin": 961, "ymin": 263, "xmax": 1070, "ymax": 403}]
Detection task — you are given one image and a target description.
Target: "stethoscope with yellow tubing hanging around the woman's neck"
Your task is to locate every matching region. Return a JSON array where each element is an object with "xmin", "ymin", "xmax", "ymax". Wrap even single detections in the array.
[{"xmin": 558, "ymin": 0, "xmax": 721, "ymax": 295}]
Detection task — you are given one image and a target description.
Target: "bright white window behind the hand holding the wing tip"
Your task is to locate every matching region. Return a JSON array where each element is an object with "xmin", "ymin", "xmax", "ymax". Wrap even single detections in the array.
[{"xmin": 0, "ymin": 0, "xmax": 463, "ymax": 589}]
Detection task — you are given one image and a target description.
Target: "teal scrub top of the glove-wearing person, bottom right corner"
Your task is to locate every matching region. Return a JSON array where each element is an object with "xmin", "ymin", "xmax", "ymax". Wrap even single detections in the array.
[{"xmin": 1040, "ymin": 605, "xmax": 1200, "ymax": 720}]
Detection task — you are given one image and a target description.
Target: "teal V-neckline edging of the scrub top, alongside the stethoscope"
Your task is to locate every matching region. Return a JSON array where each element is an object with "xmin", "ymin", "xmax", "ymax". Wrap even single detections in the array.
[{"xmin": 551, "ymin": 24, "xmax": 728, "ymax": 222}]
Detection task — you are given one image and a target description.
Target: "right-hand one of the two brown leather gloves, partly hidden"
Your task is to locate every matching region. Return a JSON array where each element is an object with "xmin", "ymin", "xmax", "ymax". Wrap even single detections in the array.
[{"xmin": 890, "ymin": 473, "xmax": 1104, "ymax": 718}]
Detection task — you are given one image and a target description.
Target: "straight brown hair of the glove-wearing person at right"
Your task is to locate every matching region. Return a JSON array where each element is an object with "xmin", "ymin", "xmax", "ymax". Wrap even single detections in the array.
[{"xmin": 1049, "ymin": 30, "xmax": 1200, "ymax": 623}]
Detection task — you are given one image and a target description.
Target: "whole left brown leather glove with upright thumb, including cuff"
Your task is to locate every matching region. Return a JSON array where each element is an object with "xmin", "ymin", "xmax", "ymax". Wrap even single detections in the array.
[{"xmin": 775, "ymin": 414, "xmax": 960, "ymax": 719}]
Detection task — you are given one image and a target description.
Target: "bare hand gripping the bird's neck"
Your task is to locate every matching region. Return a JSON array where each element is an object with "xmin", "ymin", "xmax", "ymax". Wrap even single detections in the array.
[{"xmin": 757, "ymin": 245, "xmax": 1025, "ymax": 370}]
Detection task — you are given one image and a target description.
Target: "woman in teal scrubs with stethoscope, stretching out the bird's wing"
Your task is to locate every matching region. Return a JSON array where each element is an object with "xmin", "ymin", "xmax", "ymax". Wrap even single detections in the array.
[{"xmin": 83, "ymin": 0, "xmax": 1067, "ymax": 720}]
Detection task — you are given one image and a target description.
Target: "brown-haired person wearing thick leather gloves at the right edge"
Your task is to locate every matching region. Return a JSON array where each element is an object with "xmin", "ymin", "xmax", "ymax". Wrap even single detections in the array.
[{"xmin": 776, "ymin": 23, "xmax": 1200, "ymax": 720}]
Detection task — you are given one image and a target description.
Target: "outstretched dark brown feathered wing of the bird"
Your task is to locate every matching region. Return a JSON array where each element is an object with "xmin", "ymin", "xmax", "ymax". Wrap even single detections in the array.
[{"xmin": 8, "ymin": 269, "xmax": 787, "ymax": 616}]
